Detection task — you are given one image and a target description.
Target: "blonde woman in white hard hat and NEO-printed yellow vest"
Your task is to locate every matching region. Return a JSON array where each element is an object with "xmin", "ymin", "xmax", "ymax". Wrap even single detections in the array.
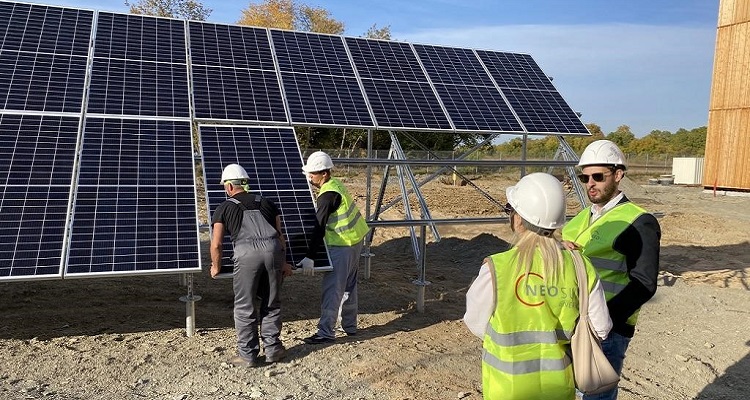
[{"xmin": 464, "ymin": 172, "xmax": 612, "ymax": 400}]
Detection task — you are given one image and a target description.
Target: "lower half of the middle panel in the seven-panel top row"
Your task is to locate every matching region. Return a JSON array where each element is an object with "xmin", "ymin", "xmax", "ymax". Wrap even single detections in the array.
[{"xmin": 281, "ymin": 72, "xmax": 374, "ymax": 128}]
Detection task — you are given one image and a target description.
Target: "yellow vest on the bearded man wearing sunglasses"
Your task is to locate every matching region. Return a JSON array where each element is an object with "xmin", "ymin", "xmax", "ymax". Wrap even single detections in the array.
[{"xmin": 562, "ymin": 202, "xmax": 646, "ymax": 326}]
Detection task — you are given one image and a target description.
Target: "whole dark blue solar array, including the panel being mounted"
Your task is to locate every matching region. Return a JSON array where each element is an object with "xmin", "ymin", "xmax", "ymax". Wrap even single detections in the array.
[{"xmin": 0, "ymin": 1, "xmax": 588, "ymax": 279}]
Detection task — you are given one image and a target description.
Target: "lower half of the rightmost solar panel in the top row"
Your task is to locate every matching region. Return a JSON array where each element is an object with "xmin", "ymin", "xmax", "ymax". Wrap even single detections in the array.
[{"xmin": 503, "ymin": 89, "xmax": 589, "ymax": 134}]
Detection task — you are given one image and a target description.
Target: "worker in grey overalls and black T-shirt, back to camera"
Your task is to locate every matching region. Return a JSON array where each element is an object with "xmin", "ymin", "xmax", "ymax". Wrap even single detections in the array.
[{"xmin": 211, "ymin": 164, "xmax": 292, "ymax": 367}]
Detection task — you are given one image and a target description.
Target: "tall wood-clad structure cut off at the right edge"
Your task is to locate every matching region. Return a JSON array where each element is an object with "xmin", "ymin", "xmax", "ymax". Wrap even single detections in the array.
[{"xmin": 703, "ymin": 0, "xmax": 750, "ymax": 192}]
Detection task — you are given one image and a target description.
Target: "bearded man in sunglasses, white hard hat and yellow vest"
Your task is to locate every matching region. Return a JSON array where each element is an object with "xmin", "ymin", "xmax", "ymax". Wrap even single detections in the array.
[{"xmin": 562, "ymin": 140, "xmax": 661, "ymax": 400}]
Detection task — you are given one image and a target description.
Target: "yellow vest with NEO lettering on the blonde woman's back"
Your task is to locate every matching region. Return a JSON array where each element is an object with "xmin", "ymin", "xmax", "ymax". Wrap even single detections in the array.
[{"xmin": 482, "ymin": 248, "xmax": 596, "ymax": 400}]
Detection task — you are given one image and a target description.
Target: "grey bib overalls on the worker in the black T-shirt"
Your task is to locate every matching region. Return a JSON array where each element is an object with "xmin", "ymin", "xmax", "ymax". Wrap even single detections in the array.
[{"xmin": 229, "ymin": 195, "xmax": 285, "ymax": 360}]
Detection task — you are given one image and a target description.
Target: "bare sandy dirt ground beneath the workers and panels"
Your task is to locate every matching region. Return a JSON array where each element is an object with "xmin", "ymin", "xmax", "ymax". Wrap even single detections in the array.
[{"xmin": 0, "ymin": 177, "xmax": 750, "ymax": 400}]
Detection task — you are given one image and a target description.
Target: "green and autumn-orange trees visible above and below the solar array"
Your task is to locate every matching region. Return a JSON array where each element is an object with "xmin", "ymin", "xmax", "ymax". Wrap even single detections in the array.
[{"xmin": 125, "ymin": 0, "xmax": 706, "ymax": 157}]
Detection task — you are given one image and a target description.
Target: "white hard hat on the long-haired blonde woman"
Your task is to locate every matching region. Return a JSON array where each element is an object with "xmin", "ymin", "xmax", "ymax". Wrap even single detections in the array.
[{"xmin": 505, "ymin": 172, "xmax": 565, "ymax": 229}]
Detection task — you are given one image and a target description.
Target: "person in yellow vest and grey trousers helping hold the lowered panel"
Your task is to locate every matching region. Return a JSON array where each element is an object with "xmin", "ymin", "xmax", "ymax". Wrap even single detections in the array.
[{"xmin": 297, "ymin": 151, "xmax": 370, "ymax": 344}]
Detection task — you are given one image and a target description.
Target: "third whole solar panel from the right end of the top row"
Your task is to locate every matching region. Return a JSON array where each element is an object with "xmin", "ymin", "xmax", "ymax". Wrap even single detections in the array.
[{"xmin": 346, "ymin": 37, "xmax": 453, "ymax": 130}]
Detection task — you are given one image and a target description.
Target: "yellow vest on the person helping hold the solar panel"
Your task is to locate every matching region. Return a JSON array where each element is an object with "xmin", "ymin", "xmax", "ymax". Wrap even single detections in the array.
[{"xmin": 319, "ymin": 178, "xmax": 370, "ymax": 246}]
